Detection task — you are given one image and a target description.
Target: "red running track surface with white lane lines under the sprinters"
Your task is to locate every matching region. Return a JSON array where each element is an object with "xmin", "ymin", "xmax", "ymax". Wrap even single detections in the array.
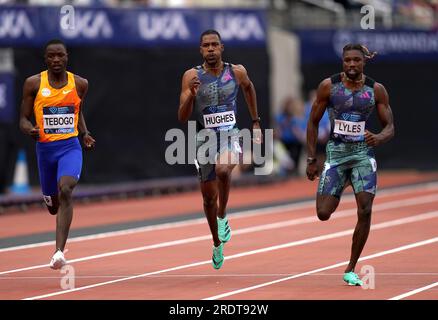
[{"xmin": 0, "ymin": 172, "xmax": 438, "ymax": 300}]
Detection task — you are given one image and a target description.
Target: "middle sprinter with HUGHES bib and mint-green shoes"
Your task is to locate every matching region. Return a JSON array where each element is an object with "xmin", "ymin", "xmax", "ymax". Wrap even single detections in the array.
[{"xmin": 178, "ymin": 30, "xmax": 262, "ymax": 269}]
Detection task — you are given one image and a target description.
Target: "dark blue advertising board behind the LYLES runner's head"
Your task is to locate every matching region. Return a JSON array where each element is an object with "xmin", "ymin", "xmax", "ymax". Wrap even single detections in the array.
[{"xmin": 294, "ymin": 30, "xmax": 438, "ymax": 63}]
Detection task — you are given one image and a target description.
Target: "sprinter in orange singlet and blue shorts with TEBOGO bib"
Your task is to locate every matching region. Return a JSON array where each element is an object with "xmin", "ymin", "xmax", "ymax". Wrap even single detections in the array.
[{"xmin": 20, "ymin": 40, "xmax": 95, "ymax": 269}]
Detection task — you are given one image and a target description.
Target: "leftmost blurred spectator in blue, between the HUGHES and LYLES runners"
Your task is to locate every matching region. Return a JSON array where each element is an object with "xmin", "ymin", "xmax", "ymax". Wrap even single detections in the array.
[{"xmin": 274, "ymin": 97, "xmax": 304, "ymax": 175}]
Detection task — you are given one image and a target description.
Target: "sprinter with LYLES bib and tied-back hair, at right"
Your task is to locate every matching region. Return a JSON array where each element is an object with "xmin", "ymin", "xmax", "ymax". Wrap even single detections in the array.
[{"xmin": 307, "ymin": 44, "xmax": 394, "ymax": 286}]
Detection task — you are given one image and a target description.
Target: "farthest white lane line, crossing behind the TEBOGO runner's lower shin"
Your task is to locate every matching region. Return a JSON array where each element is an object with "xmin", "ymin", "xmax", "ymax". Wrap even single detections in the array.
[{"xmin": 0, "ymin": 182, "xmax": 438, "ymax": 253}]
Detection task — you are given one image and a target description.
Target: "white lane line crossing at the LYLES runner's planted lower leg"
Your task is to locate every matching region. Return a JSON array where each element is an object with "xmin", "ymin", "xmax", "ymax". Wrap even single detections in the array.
[{"xmin": 203, "ymin": 237, "xmax": 438, "ymax": 300}]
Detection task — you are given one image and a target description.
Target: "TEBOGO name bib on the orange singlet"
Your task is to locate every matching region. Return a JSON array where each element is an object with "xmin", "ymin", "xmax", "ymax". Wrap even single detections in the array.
[{"xmin": 43, "ymin": 106, "xmax": 75, "ymax": 134}]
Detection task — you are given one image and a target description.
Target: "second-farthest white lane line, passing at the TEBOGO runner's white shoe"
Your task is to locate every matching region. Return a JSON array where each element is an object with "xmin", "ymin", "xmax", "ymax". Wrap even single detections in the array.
[{"xmin": 0, "ymin": 195, "xmax": 438, "ymax": 275}]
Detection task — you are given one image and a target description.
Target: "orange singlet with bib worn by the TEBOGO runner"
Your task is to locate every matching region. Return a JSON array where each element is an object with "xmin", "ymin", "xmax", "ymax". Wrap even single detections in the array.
[{"xmin": 33, "ymin": 70, "xmax": 81, "ymax": 142}]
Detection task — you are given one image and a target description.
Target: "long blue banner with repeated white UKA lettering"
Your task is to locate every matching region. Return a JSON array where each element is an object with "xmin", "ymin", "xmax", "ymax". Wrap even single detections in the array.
[{"xmin": 0, "ymin": 6, "xmax": 266, "ymax": 47}]
